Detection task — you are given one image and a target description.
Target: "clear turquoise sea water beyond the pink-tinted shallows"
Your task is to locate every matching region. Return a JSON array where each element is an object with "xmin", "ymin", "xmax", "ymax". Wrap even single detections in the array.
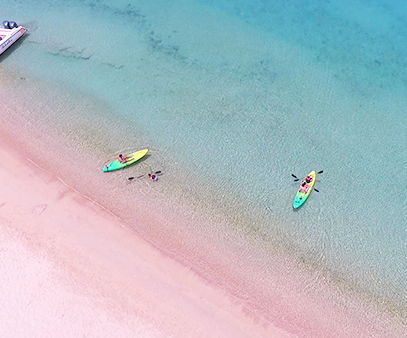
[{"xmin": 1, "ymin": 0, "xmax": 407, "ymax": 334}]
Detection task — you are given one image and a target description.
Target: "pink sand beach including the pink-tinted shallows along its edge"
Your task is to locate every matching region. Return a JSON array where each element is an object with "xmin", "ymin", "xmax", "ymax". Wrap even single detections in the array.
[{"xmin": 0, "ymin": 70, "xmax": 405, "ymax": 338}]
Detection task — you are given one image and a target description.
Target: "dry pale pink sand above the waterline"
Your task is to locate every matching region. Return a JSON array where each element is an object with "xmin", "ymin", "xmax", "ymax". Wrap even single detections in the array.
[{"xmin": 0, "ymin": 141, "xmax": 289, "ymax": 337}]
